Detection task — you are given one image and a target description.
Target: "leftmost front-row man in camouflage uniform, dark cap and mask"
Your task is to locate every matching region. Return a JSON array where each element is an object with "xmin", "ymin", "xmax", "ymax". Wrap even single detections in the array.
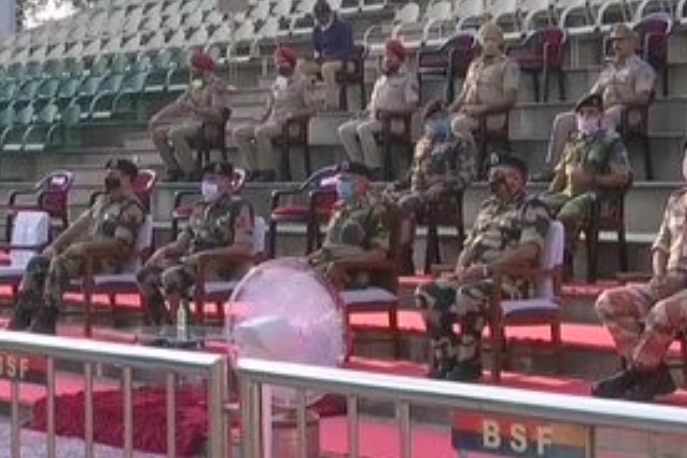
[{"xmin": 9, "ymin": 159, "xmax": 145, "ymax": 334}]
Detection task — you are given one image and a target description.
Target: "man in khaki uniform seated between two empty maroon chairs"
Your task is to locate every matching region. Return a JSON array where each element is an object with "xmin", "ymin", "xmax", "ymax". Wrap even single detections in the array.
[{"xmin": 449, "ymin": 22, "xmax": 520, "ymax": 147}]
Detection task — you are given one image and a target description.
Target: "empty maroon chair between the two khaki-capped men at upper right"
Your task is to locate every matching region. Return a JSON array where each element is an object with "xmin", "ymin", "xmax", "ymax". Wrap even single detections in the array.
[{"xmin": 508, "ymin": 26, "xmax": 568, "ymax": 102}]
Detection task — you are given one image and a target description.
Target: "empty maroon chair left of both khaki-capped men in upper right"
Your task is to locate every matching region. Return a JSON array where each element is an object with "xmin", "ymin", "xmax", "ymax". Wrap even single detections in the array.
[{"xmin": 417, "ymin": 32, "xmax": 477, "ymax": 101}]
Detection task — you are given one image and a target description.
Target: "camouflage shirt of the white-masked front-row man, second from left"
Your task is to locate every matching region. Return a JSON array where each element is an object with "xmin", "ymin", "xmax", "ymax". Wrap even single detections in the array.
[{"xmin": 179, "ymin": 195, "xmax": 254, "ymax": 253}]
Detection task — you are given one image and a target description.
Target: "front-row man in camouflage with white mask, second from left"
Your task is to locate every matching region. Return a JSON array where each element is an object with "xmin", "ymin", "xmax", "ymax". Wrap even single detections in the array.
[{"xmin": 136, "ymin": 163, "xmax": 254, "ymax": 325}]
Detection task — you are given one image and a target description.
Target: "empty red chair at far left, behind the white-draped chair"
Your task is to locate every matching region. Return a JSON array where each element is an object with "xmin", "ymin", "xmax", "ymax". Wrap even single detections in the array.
[{"xmin": 5, "ymin": 170, "xmax": 74, "ymax": 240}]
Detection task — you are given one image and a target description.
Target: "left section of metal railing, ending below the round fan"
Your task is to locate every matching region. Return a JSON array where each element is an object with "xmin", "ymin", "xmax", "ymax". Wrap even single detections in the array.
[{"xmin": 0, "ymin": 331, "xmax": 228, "ymax": 458}]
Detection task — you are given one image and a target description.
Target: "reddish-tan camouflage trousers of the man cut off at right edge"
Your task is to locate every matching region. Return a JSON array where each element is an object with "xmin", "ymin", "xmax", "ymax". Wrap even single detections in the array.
[{"xmin": 596, "ymin": 284, "xmax": 687, "ymax": 369}]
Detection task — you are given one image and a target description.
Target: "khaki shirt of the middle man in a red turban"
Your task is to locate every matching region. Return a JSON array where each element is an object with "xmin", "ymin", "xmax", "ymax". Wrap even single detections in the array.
[{"xmin": 269, "ymin": 74, "xmax": 313, "ymax": 123}]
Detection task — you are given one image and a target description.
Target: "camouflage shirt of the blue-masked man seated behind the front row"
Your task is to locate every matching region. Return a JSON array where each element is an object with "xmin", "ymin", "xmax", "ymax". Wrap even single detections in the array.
[{"xmin": 410, "ymin": 136, "xmax": 477, "ymax": 191}]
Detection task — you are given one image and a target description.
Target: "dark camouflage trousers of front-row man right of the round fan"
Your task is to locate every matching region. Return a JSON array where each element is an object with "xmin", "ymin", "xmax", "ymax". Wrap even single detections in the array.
[{"xmin": 415, "ymin": 279, "xmax": 494, "ymax": 367}]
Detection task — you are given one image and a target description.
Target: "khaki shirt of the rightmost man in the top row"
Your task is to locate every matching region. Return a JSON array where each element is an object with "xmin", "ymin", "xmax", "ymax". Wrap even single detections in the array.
[{"xmin": 590, "ymin": 54, "xmax": 656, "ymax": 108}]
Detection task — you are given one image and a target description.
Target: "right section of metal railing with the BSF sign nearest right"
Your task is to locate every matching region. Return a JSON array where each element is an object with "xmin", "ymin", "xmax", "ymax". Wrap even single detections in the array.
[{"xmin": 237, "ymin": 359, "xmax": 687, "ymax": 458}]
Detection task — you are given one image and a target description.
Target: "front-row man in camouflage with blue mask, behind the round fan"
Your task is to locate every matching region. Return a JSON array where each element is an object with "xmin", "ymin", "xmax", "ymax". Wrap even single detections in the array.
[{"xmin": 309, "ymin": 162, "xmax": 390, "ymax": 288}]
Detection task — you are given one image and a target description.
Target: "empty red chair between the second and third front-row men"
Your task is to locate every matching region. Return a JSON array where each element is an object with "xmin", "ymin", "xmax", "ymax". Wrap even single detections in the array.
[{"xmin": 267, "ymin": 166, "xmax": 337, "ymax": 258}]
